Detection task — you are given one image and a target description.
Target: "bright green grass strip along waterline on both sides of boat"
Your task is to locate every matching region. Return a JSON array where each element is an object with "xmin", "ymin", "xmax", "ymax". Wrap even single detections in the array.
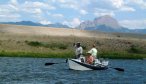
[{"xmin": 0, "ymin": 51, "xmax": 146, "ymax": 59}]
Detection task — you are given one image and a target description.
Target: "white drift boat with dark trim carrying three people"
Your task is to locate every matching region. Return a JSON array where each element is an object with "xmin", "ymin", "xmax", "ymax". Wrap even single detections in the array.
[{"xmin": 68, "ymin": 58, "xmax": 108, "ymax": 70}]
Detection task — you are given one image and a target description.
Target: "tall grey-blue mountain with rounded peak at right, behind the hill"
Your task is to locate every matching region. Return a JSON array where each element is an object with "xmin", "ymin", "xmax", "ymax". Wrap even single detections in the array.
[{"xmin": 78, "ymin": 15, "xmax": 146, "ymax": 34}]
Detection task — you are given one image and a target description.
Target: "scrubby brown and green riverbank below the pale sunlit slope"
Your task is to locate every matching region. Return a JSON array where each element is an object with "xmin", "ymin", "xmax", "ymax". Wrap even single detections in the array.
[{"xmin": 0, "ymin": 33, "xmax": 146, "ymax": 59}]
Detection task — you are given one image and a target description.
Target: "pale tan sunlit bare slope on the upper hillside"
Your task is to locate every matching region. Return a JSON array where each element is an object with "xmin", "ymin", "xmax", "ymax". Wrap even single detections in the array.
[{"xmin": 0, "ymin": 24, "xmax": 118, "ymax": 37}]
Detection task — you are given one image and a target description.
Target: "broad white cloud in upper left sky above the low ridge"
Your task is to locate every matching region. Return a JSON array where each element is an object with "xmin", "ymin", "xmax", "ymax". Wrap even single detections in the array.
[{"xmin": 19, "ymin": 1, "xmax": 56, "ymax": 23}]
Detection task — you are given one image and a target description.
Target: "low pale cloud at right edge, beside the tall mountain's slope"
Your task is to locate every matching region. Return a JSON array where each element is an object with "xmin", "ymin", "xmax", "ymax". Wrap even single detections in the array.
[{"xmin": 120, "ymin": 20, "xmax": 146, "ymax": 29}]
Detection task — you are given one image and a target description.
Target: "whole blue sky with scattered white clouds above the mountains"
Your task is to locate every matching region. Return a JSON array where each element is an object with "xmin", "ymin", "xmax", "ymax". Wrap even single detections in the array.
[{"xmin": 0, "ymin": 0, "xmax": 146, "ymax": 29}]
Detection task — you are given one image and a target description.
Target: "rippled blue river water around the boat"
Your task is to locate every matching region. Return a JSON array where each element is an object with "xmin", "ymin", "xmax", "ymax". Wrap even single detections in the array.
[{"xmin": 0, "ymin": 57, "xmax": 146, "ymax": 84}]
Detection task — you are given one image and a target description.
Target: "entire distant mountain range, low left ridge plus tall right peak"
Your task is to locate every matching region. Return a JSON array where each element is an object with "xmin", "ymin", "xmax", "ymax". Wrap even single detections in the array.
[{"xmin": 0, "ymin": 15, "xmax": 146, "ymax": 34}]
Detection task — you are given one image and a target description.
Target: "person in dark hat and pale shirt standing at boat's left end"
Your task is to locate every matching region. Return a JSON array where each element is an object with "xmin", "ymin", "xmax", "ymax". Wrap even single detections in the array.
[{"xmin": 73, "ymin": 42, "xmax": 83, "ymax": 59}]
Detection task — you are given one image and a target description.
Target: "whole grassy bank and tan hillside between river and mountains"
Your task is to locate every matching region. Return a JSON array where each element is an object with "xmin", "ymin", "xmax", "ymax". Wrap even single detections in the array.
[{"xmin": 0, "ymin": 25, "xmax": 146, "ymax": 59}]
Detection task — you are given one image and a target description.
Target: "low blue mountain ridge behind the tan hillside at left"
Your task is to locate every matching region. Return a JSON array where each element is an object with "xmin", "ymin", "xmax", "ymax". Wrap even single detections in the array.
[{"xmin": 1, "ymin": 21, "xmax": 69, "ymax": 28}]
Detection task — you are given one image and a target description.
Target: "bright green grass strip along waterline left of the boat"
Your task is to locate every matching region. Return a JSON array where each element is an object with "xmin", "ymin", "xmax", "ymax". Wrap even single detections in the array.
[{"xmin": 0, "ymin": 51, "xmax": 73, "ymax": 58}]
